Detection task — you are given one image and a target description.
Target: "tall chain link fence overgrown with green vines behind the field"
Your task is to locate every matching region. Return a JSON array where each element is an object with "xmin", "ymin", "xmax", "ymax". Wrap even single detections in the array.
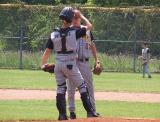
[{"xmin": 0, "ymin": 5, "xmax": 160, "ymax": 72}]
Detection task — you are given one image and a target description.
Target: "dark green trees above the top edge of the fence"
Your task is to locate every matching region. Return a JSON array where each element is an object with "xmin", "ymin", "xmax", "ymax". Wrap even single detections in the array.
[{"xmin": 0, "ymin": 0, "xmax": 160, "ymax": 6}]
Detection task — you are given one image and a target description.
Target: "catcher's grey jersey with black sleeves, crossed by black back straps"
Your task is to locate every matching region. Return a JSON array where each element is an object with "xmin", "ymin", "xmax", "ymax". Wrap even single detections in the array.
[{"xmin": 46, "ymin": 27, "xmax": 86, "ymax": 61}]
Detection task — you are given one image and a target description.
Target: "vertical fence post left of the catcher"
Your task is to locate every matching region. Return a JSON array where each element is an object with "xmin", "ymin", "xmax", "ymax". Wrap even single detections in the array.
[{"xmin": 19, "ymin": 12, "xmax": 24, "ymax": 69}]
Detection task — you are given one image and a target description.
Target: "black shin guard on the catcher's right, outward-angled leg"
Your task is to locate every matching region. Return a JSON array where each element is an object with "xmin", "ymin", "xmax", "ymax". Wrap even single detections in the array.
[{"xmin": 81, "ymin": 92, "xmax": 99, "ymax": 117}]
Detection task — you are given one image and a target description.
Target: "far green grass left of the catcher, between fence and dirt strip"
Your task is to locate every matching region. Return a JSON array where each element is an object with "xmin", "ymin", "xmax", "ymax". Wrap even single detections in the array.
[{"xmin": 0, "ymin": 69, "xmax": 56, "ymax": 89}]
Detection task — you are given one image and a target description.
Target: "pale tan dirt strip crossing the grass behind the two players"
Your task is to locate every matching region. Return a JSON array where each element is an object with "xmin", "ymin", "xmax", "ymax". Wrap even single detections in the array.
[{"xmin": 0, "ymin": 89, "xmax": 160, "ymax": 103}]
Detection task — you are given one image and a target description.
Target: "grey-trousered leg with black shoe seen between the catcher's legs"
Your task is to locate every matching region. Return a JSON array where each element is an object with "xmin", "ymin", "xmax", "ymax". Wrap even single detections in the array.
[{"xmin": 67, "ymin": 81, "xmax": 76, "ymax": 119}]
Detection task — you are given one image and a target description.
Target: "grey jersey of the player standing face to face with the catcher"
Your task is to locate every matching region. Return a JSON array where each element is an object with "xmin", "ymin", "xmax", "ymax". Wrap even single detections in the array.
[{"xmin": 77, "ymin": 26, "xmax": 94, "ymax": 59}]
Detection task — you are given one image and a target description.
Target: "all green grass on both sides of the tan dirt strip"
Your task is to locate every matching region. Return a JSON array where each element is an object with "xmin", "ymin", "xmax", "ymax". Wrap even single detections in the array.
[{"xmin": 0, "ymin": 69, "xmax": 160, "ymax": 120}]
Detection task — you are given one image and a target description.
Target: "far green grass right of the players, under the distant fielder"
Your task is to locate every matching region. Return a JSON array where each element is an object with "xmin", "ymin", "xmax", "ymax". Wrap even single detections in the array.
[{"xmin": 94, "ymin": 73, "xmax": 160, "ymax": 93}]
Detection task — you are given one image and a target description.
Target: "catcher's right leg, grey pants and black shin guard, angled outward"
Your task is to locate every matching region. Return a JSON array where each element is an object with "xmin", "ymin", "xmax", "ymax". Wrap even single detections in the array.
[{"xmin": 66, "ymin": 62, "xmax": 97, "ymax": 117}]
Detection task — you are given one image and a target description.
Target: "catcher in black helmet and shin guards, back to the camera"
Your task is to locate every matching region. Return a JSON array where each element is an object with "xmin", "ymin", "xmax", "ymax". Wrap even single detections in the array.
[{"xmin": 41, "ymin": 7, "xmax": 98, "ymax": 120}]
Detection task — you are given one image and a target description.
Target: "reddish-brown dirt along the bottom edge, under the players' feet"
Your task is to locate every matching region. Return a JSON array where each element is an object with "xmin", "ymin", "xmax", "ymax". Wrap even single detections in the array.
[{"xmin": 2, "ymin": 118, "xmax": 160, "ymax": 122}]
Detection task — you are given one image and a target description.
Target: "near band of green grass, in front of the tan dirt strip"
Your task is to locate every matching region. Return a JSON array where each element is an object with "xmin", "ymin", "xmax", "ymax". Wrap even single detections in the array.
[{"xmin": 0, "ymin": 100, "xmax": 160, "ymax": 120}]
